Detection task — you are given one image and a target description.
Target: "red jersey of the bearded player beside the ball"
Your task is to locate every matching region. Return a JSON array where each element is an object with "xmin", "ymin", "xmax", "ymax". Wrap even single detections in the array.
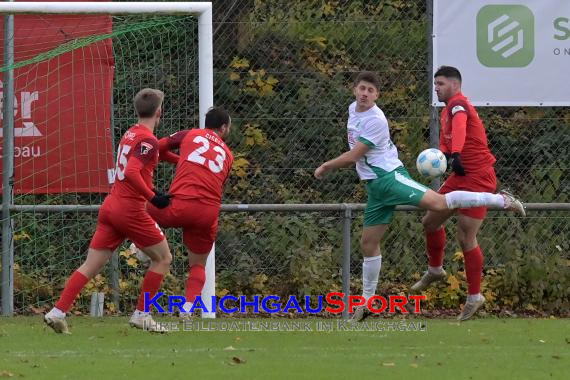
[{"xmin": 439, "ymin": 92, "xmax": 496, "ymax": 173}]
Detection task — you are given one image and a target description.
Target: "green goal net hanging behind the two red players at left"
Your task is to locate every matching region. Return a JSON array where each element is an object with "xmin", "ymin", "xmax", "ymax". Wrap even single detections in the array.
[{"xmin": 0, "ymin": 3, "xmax": 212, "ymax": 315}]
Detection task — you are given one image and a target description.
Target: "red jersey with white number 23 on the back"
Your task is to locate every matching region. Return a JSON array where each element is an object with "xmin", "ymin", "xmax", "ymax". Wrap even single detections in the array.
[{"xmin": 159, "ymin": 129, "xmax": 234, "ymax": 205}]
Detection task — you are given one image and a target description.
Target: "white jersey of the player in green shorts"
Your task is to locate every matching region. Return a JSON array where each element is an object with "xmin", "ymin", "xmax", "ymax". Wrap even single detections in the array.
[{"xmin": 347, "ymin": 102, "xmax": 403, "ymax": 180}]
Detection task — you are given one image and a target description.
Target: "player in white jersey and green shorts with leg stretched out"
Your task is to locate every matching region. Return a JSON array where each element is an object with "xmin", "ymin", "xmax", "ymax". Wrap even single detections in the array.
[{"xmin": 314, "ymin": 72, "xmax": 524, "ymax": 321}]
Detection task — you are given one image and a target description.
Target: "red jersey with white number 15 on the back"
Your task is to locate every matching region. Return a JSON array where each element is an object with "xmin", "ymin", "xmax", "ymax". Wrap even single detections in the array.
[{"xmin": 111, "ymin": 124, "xmax": 158, "ymax": 202}]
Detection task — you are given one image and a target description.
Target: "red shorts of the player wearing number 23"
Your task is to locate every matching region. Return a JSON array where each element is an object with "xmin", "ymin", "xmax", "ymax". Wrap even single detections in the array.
[{"xmin": 147, "ymin": 197, "xmax": 220, "ymax": 255}]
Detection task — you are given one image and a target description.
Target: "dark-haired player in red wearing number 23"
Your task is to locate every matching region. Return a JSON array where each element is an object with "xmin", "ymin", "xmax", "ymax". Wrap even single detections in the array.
[{"xmin": 147, "ymin": 107, "xmax": 234, "ymax": 319}]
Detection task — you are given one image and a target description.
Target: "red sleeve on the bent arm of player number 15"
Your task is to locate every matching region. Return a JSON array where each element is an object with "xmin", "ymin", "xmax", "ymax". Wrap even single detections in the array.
[{"xmin": 125, "ymin": 138, "xmax": 158, "ymax": 200}]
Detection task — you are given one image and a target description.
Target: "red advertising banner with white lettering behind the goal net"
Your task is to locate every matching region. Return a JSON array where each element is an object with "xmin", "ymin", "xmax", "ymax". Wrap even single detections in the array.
[{"xmin": 0, "ymin": 11, "xmax": 114, "ymax": 194}]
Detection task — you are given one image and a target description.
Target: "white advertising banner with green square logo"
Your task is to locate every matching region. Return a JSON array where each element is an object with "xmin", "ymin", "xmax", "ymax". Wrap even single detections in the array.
[{"xmin": 432, "ymin": 0, "xmax": 570, "ymax": 106}]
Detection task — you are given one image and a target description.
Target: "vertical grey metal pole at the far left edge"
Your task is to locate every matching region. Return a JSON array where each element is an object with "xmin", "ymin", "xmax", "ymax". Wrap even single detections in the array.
[{"xmin": 2, "ymin": 7, "xmax": 14, "ymax": 316}]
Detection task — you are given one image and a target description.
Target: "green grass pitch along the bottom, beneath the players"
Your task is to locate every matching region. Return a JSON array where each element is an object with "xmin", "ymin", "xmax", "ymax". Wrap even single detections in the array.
[{"xmin": 0, "ymin": 317, "xmax": 570, "ymax": 380}]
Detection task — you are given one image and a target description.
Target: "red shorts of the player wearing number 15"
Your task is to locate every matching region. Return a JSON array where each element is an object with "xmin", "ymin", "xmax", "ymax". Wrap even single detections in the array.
[{"xmin": 89, "ymin": 196, "xmax": 164, "ymax": 251}]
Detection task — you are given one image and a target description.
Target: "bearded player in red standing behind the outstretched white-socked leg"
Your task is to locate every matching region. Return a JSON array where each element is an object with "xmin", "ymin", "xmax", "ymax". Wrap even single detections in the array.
[{"xmin": 412, "ymin": 66, "xmax": 508, "ymax": 321}]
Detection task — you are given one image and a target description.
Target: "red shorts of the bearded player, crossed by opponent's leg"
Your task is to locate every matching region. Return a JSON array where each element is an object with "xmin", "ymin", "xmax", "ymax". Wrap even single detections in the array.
[{"xmin": 438, "ymin": 166, "xmax": 497, "ymax": 219}]
